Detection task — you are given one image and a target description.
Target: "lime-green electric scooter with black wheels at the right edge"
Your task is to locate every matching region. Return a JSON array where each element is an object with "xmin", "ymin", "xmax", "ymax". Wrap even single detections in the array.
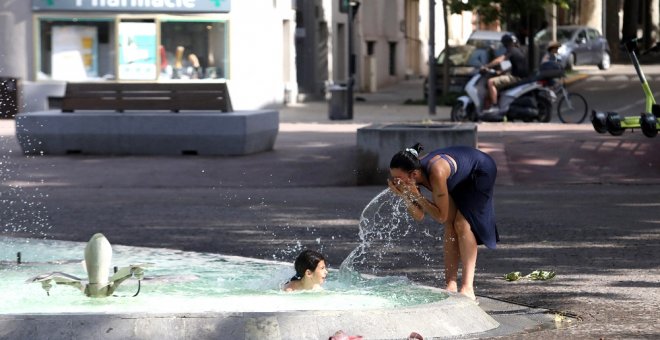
[{"xmin": 591, "ymin": 39, "xmax": 660, "ymax": 137}]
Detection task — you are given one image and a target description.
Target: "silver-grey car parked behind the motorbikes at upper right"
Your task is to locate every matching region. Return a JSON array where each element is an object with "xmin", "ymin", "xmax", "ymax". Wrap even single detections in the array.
[{"xmin": 534, "ymin": 26, "xmax": 610, "ymax": 70}]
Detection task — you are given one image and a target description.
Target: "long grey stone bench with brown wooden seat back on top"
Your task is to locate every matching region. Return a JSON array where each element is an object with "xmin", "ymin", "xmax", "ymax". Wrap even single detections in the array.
[{"xmin": 16, "ymin": 83, "xmax": 279, "ymax": 156}]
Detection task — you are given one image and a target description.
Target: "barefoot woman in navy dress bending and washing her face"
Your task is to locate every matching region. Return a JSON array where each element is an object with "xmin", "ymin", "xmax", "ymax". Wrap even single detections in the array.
[{"xmin": 388, "ymin": 143, "xmax": 499, "ymax": 299}]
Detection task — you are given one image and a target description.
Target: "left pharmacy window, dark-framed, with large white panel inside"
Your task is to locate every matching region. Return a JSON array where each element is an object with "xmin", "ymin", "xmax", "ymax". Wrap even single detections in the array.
[{"xmin": 37, "ymin": 19, "xmax": 115, "ymax": 81}]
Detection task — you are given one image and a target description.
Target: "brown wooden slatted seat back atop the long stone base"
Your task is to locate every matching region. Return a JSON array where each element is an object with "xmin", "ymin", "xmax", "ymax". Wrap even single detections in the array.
[{"xmin": 61, "ymin": 82, "xmax": 234, "ymax": 112}]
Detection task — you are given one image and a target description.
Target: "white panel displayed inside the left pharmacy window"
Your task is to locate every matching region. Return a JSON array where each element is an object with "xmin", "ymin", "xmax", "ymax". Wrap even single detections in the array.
[{"xmin": 51, "ymin": 26, "xmax": 98, "ymax": 81}]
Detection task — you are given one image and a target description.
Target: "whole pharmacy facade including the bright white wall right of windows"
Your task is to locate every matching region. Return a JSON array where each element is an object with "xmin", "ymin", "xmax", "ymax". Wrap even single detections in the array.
[{"xmin": 0, "ymin": 0, "xmax": 297, "ymax": 111}]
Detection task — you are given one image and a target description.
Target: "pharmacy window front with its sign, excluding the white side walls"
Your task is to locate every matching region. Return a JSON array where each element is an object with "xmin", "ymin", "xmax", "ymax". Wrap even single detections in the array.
[{"xmin": 32, "ymin": 0, "xmax": 231, "ymax": 81}]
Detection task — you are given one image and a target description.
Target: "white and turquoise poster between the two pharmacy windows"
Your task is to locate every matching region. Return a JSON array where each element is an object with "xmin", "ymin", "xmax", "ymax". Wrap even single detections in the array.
[{"xmin": 119, "ymin": 22, "xmax": 158, "ymax": 80}]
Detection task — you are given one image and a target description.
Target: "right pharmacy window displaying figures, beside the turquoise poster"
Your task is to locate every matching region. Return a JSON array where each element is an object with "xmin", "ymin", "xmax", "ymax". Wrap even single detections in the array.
[{"xmin": 159, "ymin": 21, "xmax": 229, "ymax": 79}]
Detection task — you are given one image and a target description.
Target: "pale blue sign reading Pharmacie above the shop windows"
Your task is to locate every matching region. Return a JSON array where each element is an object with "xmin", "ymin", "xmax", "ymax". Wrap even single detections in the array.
[{"xmin": 32, "ymin": 0, "xmax": 231, "ymax": 13}]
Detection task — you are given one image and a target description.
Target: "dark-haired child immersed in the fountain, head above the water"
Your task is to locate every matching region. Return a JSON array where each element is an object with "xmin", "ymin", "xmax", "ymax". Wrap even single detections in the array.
[{"xmin": 282, "ymin": 249, "xmax": 328, "ymax": 292}]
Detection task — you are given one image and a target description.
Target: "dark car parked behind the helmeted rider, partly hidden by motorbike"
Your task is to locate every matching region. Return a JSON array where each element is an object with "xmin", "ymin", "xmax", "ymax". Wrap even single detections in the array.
[{"xmin": 423, "ymin": 31, "xmax": 513, "ymax": 99}]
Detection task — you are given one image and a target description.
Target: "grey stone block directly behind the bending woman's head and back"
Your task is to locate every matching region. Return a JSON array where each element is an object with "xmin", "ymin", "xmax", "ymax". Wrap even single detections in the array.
[{"xmin": 357, "ymin": 123, "xmax": 477, "ymax": 185}]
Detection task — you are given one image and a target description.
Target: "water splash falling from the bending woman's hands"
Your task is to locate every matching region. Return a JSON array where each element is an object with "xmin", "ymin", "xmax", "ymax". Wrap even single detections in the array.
[{"xmin": 340, "ymin": 189, "xmax": 442, "ymax": 280}]
